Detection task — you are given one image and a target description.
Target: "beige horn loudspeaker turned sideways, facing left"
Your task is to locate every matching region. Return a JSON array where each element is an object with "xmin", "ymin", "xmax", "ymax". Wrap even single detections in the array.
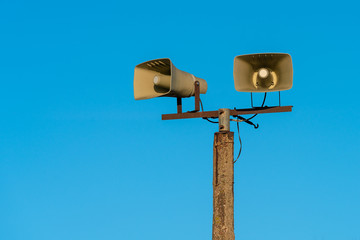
[{"xmin": 134, "ymin": 58, "xmax": 207, "ymax": 100}]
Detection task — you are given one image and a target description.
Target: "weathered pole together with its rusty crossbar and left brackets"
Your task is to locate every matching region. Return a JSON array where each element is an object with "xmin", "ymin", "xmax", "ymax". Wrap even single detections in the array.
[{"xmin": 162, "ymin": 103, "xmax": 292, "ymax": 240}]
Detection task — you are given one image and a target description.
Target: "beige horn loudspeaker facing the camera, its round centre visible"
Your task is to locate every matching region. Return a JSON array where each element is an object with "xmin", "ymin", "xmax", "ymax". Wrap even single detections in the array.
[{"xmin": 234, "ymin": 53, "xmax": 293, "ymax": 92}]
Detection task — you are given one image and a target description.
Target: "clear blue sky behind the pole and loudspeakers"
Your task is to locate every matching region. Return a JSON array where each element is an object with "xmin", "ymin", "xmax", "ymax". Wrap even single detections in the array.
[{"xmin": 0, "ymin": 0, "xmax": 360, "ymax": 240}]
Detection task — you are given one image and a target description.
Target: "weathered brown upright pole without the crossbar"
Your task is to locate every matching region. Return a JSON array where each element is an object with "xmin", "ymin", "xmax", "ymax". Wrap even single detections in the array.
[{"xmin": 212, "ymin": 109, "xmax": 235, "ymax": 240}]
